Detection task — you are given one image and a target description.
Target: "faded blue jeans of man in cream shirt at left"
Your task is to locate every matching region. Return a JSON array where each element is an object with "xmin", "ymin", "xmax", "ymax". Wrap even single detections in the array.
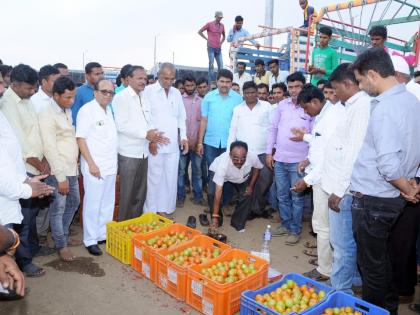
[{"xmin": 48, "ymin": 176, "xmax": 80, "ymax": 250}]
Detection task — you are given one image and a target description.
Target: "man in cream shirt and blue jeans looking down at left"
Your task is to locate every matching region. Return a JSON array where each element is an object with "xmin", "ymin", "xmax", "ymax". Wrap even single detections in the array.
[{"xmin": 39, "ymin": 76, "xmax": 81, "ymax": 261}]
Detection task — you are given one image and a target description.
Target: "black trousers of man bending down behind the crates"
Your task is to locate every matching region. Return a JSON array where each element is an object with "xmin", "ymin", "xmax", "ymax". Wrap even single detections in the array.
[{"xmin": 207, "ymin": 171, "xmax": 252, "ymax": 231}]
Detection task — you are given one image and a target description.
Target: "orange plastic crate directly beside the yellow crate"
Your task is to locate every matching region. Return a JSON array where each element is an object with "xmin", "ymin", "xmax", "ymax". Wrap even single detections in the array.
[{"xmin": 131, "ymin": 223, "xmax": 201, "ymax": 282}]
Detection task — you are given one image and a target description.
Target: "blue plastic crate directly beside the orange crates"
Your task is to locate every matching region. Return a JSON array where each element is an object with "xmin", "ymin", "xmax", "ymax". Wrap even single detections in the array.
[{"xmin": 240, "ymin": 272, "xmax": 332, "ymax": 315}]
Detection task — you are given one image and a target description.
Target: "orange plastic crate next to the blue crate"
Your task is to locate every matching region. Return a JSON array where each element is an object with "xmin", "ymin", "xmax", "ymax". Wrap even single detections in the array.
[{"xmin": 187, "ymin": 249, "xmax": 269, "ymax": 315}]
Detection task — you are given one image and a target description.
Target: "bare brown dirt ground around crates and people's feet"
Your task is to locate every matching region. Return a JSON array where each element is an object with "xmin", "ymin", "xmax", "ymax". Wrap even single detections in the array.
[{"xmin": 0, "ymin": 201, "xmax": 420, "ymax": 315}]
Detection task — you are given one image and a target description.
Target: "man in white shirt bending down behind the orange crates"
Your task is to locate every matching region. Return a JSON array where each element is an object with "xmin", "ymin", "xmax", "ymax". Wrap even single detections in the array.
[{"xmin": 208, "ymin": 141, "xmax": 263, "ymax": 232}]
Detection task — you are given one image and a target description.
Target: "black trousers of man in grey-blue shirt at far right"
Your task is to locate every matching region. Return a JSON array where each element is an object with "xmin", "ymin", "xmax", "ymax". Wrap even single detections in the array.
[{"xmin": 352, "ymin": 196, "xmax": 405, "ymax": 315}]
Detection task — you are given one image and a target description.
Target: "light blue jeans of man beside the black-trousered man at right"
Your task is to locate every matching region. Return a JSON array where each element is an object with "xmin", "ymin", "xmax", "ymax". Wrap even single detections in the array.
[{"xmin": 329, "ymin": 194, "xmax": 362, "ymax": 294}]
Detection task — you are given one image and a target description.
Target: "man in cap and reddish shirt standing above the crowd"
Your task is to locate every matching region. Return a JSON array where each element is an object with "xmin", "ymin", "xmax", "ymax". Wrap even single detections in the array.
[{"xmin": 198, "ymin": 11, "xmax": 225, "ymax": 81}]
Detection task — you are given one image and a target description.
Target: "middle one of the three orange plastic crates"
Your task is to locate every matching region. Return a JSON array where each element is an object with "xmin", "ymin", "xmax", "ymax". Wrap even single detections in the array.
[{"xmin": 156, "ymin": 235, "xmax": 231, "ymax": 301}]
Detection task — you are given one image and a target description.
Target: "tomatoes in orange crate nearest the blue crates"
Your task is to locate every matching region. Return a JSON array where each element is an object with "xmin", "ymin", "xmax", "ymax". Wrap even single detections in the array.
[{"xmin": 200, "ymin": 258, "xmax": 256, "ymax": 284}]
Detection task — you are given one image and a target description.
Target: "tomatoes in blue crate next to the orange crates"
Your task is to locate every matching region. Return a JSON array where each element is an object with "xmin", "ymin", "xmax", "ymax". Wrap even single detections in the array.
[{"xmin": 255, "ymin": 280, "xmax": 326, "ymax": 314}]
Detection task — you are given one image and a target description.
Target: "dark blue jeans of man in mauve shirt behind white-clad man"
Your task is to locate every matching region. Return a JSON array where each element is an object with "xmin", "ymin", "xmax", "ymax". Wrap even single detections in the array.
[{"xmin": 178, "ymin": 150, "xmax": 203, "ymax": 201}]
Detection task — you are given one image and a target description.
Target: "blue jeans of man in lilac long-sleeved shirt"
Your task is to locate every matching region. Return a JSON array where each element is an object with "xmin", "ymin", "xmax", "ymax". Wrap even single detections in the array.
[{"xmin": 274, "ymin": 162, "xmax": 305, "ymax": 235}]
